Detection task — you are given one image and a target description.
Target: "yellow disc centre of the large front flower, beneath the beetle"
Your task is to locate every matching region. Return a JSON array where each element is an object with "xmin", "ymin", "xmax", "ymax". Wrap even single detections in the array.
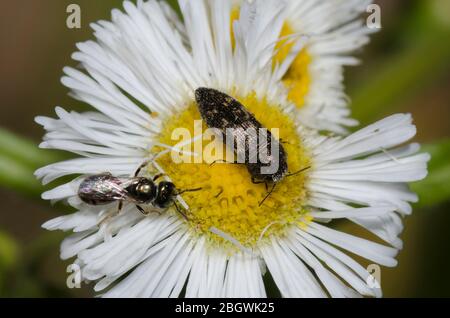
[{"xmin": 153, "ymin": 94, "xmax": 311, "ymax": 248}]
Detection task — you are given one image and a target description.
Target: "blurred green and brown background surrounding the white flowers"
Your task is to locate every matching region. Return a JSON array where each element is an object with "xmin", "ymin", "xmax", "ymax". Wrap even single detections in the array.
[{"xmin": 0, "ymin": 0, "xmax": 450, "ymax": 297}]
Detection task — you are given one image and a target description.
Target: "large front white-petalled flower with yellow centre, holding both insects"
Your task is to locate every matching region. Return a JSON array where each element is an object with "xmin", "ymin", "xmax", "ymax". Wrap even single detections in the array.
[{"xmin": 36, "ymin": 0, "xmax": 429, "ymax": 297}]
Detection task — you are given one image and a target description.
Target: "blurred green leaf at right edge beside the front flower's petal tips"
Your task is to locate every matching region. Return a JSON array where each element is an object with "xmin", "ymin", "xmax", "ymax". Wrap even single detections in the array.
[{"xmin": 411, "ymin": 139, "xmax": 450, "ymax": 207}]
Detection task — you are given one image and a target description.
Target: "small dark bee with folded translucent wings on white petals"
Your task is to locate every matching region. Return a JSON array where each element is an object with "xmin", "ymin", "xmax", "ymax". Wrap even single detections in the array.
[{"xmin": 78, "ymin": 163, "xmax": 201, "ymax": 219}]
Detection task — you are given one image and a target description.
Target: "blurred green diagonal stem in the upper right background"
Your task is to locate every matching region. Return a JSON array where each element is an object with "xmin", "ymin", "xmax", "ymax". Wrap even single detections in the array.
[{"xmin": 351, "ymin": 29, "xmax": 450, "ymax": 125}]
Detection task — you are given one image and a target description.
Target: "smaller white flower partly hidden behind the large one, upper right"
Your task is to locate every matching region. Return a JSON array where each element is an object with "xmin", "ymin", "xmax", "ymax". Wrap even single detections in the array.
[{"xmin": 232, "ymin": 0, "xmax": 376, "ymax": 134}]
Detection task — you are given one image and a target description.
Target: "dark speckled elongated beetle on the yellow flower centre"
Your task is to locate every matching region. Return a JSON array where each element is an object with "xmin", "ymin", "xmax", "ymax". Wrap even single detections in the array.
[{"xmin": 195, "ymin": 87, "xmax": 308, "ymax": 204}]
